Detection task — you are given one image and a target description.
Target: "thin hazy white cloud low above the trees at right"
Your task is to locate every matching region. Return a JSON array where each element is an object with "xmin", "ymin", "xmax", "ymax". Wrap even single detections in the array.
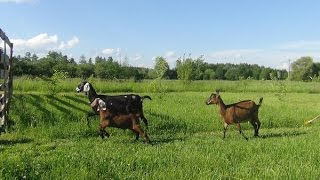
[{"xmin": 205, "ymin": 44, "xmax": 320, "ymax": 70}]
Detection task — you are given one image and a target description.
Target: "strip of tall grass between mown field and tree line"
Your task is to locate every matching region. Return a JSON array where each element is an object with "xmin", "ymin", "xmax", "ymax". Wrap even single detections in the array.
[{"xmin": 14, "ymin": 77, "xmax": 320, "ymax": 93}]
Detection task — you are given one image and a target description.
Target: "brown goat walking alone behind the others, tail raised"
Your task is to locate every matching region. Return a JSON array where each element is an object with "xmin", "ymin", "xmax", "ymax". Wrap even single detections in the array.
[{"xmin": 206, "ymin": 90, "xmax": 263, "ymax": 140}]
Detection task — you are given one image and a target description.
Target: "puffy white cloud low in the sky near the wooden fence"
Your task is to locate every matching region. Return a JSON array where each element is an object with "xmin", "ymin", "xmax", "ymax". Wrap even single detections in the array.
[{"xmin": 12, "ymin": 33, "xmax": 79, "ymax": 55}]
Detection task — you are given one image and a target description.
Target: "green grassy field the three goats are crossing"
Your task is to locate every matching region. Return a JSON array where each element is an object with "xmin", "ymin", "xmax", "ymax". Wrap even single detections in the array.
[{"xmin": 0, "ymin": 79, "xmax": 320, "ymax": 179}]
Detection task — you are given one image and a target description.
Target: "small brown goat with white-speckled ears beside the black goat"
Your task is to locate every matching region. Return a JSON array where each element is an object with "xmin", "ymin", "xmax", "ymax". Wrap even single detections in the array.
[{"xmin": 91, "ymin": 98, "xmax": 150, "ymax": 143}]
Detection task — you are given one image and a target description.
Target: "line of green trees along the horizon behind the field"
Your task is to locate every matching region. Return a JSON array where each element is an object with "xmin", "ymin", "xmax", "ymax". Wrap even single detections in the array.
[{"xmin": 13, "ymin": 51, "xmax": 320, "ymax": 81}]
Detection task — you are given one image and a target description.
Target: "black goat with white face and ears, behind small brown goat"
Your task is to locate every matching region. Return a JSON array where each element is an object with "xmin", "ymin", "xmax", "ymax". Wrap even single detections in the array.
[{"xmin": 76, "ymin": 81, "xmax": 151, "ymax": 129}]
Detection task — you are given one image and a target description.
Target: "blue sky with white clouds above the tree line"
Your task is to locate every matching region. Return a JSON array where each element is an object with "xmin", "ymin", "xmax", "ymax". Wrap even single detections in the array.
[{"xmin": 0, "ymin": 0, "xmax": 320, "ymax": 69}]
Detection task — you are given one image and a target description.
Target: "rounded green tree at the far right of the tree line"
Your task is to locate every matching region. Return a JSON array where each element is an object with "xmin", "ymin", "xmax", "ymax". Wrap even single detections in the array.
[{"xmin": 291, "ymin": 56, "xmax": 317, "ymax": 81}]
